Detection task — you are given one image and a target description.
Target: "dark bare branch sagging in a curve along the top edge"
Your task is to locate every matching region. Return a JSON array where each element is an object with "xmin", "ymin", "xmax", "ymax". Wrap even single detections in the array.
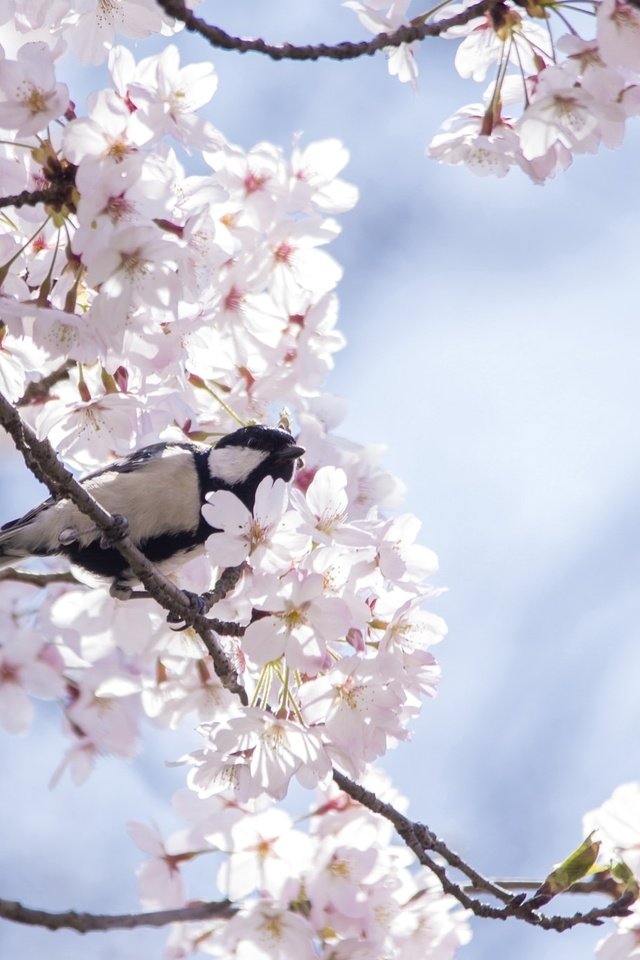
[{"xmin": 157, "ymin": 0, "xmax": 499, "ymax": 61}]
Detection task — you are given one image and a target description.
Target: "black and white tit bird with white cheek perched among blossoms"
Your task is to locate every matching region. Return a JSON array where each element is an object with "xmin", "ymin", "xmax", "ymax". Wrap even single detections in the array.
[{"xmin": 0, "ymin": 425, "xmax": 304, "ymax": 599}]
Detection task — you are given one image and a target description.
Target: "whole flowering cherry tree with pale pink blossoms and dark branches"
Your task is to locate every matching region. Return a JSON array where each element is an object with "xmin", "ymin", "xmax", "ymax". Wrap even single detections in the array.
[{"xmin": 0, "ymin": 0, "xmax": 640, "ymax": 960}]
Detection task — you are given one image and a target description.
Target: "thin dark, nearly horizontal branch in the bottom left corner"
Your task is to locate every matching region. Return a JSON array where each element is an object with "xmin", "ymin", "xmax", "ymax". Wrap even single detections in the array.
[{"xmin": 0, "ymin": 899, "xmax": 237, "ymax": 933}]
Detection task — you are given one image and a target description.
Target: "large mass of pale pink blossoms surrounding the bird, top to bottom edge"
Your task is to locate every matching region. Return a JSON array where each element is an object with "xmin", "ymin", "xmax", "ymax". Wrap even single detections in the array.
[{"xmin": 0, "ymin": 0, "xmax": 467, "ymax": 960}]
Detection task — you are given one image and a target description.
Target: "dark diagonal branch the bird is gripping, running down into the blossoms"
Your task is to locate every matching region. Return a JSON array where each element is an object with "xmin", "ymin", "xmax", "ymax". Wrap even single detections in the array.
[{"xmin": 0, "ymin": 394, "xmax": 246, "ymax": 703}]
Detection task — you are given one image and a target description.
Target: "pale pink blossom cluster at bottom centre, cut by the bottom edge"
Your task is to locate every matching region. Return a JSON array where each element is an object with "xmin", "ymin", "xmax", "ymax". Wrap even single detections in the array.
[{"xmin": 129, "ymin": 775, "xmax": 469, "ymax": 960}]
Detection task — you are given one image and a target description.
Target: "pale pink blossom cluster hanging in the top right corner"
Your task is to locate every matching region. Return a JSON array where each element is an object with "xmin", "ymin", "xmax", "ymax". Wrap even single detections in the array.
[{"xmin": 344, "ymin": 0, "xmax": 640, "ymax": 183}]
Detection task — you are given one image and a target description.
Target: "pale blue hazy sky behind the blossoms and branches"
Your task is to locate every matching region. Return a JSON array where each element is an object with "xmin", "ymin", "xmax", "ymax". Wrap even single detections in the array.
[{"xmin": 0, "ymin": 7, "xmax": 640, "ymax": 960}]
